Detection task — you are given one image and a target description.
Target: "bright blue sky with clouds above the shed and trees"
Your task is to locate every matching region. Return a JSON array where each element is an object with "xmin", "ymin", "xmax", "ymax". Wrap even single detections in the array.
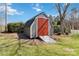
[{"xmin": 1, "ymin": 3, "xmax": 79, "ymax": 22}]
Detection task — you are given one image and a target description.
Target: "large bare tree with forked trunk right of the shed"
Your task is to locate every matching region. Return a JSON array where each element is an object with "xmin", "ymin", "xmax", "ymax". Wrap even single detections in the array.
[{"xmin": 56, "ymin": 3, "xmax": 70, "ymax": 34}]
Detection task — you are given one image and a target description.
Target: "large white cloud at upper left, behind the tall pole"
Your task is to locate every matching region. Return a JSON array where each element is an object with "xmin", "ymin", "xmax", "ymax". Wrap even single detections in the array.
[{"xmin": 0, "ymin": 4, "xmax": 24, "ymax": 15}]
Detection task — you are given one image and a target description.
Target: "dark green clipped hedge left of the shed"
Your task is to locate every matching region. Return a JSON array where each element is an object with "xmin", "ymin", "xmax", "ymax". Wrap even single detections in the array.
[{"xmin": 7, "ymin": 22, "xmax": 24, "ymax": 33}]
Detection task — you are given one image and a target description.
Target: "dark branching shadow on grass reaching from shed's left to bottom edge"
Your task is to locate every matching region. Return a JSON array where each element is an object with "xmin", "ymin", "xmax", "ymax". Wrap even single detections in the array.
[{"xmin": 10, "ymin": 33, "xmax": 29, "ymax": 56}]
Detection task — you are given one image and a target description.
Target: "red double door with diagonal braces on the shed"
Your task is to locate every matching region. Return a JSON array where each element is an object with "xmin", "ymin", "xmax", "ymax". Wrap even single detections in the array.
[{"xmin": 38, "ymin": 18, "xmax": 48, "ymax": 36}]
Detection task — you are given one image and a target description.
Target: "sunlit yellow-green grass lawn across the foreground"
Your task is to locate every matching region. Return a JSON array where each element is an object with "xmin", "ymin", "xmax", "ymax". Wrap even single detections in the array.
[{"xmin": 0, "ymin": 34, "xmax": 79, "ymax": 56}]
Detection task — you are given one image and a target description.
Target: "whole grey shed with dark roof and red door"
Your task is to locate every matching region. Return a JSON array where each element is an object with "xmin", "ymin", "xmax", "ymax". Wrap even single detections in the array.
[{"xmin": 24, "ymin": 12, "xmax": 51, "ymax": 38}]
